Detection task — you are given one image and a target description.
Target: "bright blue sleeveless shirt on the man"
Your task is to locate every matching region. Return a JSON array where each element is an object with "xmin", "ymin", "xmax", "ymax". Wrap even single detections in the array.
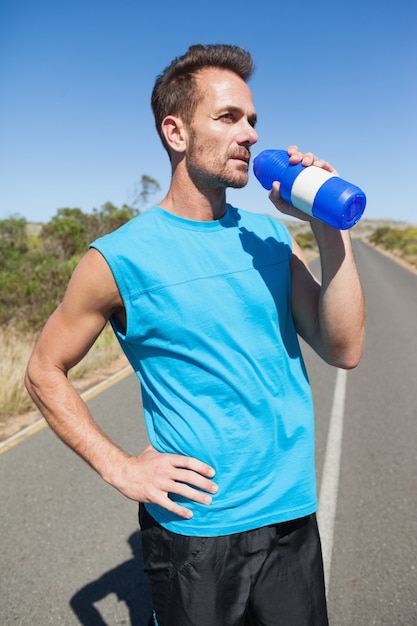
[{"xmin": 92, "ymin": 205, "xmax": 317, "ymax": 536}]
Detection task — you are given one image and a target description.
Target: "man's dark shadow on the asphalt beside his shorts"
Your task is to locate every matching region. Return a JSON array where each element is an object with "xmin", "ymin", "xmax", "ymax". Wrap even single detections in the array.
[{"xmin": 70, "ymin": 531, "xmax": 154, "ymax": 626}]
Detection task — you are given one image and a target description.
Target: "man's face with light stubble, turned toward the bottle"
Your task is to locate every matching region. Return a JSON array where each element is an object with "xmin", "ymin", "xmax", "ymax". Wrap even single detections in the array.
[{"xmin": 186, "ymin": 68, "xmax": 258, "ymax": 188}]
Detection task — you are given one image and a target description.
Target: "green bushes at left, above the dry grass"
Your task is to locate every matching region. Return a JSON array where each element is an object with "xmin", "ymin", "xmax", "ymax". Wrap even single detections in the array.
[{"xmin": 0, "ymin": 175, "xmax": 159, "ymax": 329}]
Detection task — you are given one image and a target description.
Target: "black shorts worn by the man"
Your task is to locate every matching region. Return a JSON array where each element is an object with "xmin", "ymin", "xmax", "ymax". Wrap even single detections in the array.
[{"xmin": 139, "ymin": 505, "xmax": 328, "ymax": 626}]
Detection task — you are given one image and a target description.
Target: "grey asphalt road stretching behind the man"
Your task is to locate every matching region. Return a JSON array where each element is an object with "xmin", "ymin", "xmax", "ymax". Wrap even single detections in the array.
[{"xmin": 0, "ymin": 242, "xmax": 417, "ymax": 626}]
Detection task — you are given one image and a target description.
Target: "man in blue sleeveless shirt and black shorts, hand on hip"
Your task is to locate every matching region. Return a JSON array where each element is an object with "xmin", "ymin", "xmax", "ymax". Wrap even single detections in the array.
[{"xmin": 27, "ymin": 45, "xmax": 364, "ymax": 626}]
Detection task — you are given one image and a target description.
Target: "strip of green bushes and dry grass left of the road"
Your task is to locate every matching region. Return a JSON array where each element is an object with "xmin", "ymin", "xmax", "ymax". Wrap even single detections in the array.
[{"xmin": 0, "ymin": 175, "xmax": 159, "ymax": 425}]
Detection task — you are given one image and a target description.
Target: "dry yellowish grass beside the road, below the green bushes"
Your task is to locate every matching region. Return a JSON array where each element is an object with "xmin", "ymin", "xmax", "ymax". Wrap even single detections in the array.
[{"xmin": 0, "ymin": 324, "xmax": 122, "ymax": 425}]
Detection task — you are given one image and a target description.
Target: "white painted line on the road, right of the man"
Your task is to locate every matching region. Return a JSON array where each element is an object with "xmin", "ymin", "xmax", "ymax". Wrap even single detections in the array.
[{"xmin": 317, "ymin": 369, "xmax": 347, "ymax": 589}]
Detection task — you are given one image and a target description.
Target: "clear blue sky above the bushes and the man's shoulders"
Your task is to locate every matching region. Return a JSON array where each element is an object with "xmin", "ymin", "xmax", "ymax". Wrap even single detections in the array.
[{"xmin": 0, "ymin": 0, "xmax": 417, "ymax": 222}]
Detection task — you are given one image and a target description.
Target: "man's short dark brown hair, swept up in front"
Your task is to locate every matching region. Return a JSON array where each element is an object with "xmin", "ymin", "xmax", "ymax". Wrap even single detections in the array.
[{"xmin": 151, "ymin": 44, "xmax": 254, "ymax": 154}]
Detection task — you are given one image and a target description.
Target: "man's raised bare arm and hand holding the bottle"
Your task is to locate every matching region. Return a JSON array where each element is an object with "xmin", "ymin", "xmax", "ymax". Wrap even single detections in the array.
[{"xmin": 270, "ymin": 146, "xmax": 365, "ymax": 369}]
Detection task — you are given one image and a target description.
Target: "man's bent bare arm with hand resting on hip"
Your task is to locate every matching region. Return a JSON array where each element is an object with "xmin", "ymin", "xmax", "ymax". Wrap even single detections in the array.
[{"xmin": 25, "ymin": 250, "xmax": 217, "ymax": 517}]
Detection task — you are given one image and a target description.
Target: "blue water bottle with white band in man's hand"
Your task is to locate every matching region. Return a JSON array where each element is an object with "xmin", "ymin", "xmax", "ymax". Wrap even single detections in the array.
[{"xmin": 253, "ymin": 150, "xmax": 366, "ymax": 230}]
